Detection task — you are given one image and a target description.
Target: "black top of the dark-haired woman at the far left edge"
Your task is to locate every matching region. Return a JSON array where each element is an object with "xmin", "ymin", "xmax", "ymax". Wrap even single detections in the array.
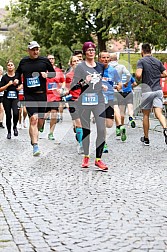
[{"xmin": 0, "ymin": 74, "xmax": 19, "ymax": 99}]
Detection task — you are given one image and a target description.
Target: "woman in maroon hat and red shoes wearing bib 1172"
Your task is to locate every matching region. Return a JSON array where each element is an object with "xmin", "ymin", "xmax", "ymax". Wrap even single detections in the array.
[{"xmin": 71, "ymin": 41, "xmax": 108, "ymax": 171}]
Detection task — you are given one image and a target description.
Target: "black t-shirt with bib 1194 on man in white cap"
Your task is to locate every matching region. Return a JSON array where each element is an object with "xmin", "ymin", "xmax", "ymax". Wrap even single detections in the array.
[{"xmin": 16, "ymin": 56, "xmax": 55, "ymax": 96}]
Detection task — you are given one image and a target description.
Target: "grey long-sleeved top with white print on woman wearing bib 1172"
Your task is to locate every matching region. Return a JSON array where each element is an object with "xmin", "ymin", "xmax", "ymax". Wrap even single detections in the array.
[{"xmin": 71, "ymin": 61, "xmax": 104, "ymax": 105}]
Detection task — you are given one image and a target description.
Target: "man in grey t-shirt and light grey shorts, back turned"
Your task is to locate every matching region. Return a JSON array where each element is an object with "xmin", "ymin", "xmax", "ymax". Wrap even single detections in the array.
[{"xmin": 136, "ymin": 43, "xmax": 167, "ymax": 145}]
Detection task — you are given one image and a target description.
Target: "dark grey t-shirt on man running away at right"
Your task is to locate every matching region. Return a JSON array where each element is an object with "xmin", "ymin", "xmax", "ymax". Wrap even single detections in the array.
[{"xmin": 137, "ymin": 55, "xmax": 165, "ymax": 93}]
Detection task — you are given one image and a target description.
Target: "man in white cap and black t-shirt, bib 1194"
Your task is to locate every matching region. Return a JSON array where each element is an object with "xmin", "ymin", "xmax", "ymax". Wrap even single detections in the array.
[{"xmin": 15, "ymin": 41, "xmax": 55, "ymax": 156}]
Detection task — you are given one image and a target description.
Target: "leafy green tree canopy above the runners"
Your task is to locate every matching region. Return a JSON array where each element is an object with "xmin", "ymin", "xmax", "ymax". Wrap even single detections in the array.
[{"xmin": 7, "ymin": 0, "xmax": 167, "ymax": 54}]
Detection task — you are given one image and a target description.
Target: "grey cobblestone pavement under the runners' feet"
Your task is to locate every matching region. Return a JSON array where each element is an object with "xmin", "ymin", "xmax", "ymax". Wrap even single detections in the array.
[{"xmin": 0, "ymin": 110, "xmax": 167, "ymax": 252}]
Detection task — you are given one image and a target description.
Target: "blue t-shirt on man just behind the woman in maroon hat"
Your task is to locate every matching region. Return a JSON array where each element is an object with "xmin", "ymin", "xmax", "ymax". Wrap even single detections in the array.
[{"xmin": 102, "ymin": 66, "xmax": 121, "ymax": 100}]
